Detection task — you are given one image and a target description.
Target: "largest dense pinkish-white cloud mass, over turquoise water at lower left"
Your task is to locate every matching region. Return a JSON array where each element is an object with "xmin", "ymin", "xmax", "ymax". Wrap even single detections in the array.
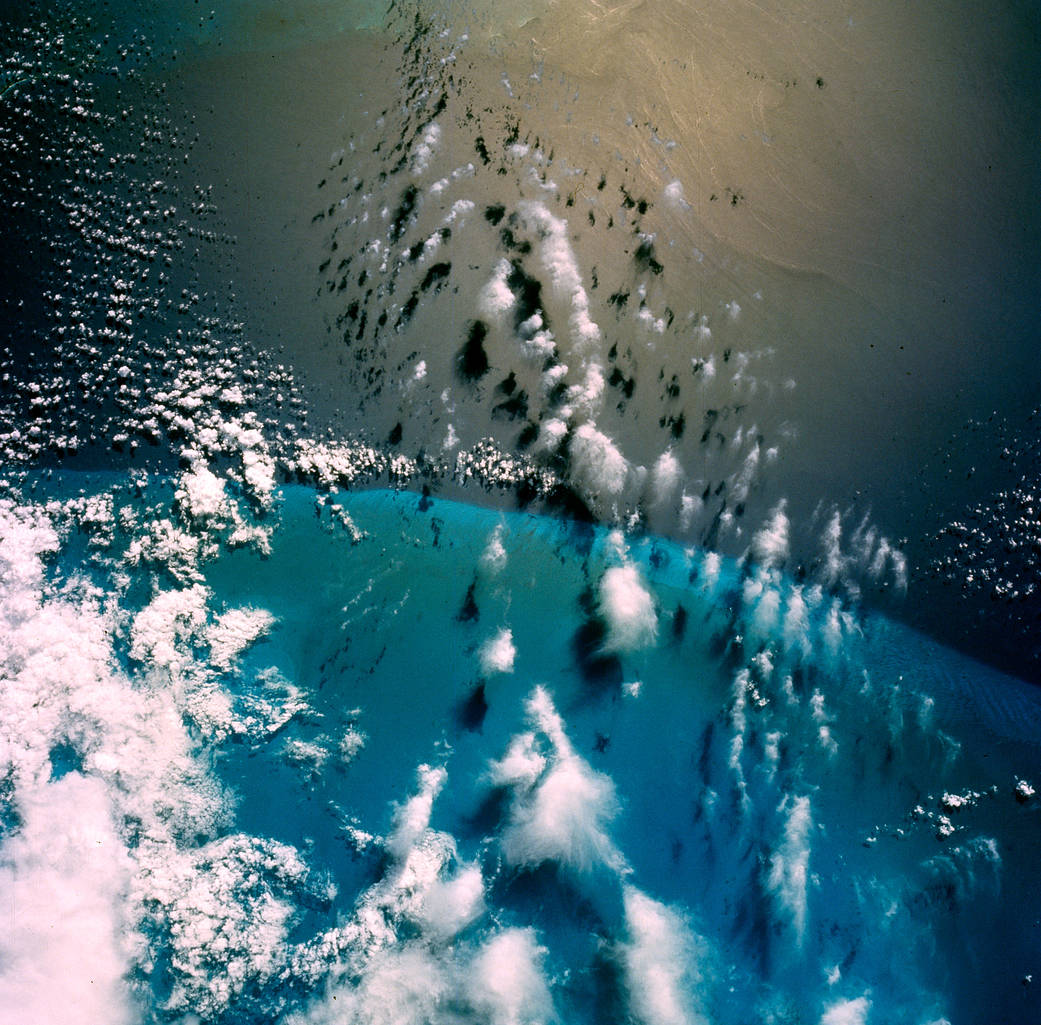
[{"xmin": 0, "ymin": 491, "xmax": 316, "ymax": 1023}]
